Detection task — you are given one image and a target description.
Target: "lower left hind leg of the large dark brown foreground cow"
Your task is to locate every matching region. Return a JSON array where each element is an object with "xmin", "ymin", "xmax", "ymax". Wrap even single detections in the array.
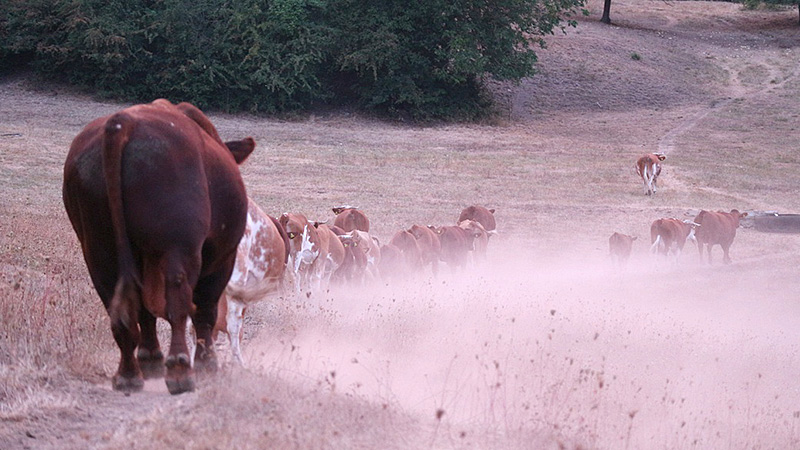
[{"xmin": 108, "ymin": 279, "xmax": 144, "ymax": 392}]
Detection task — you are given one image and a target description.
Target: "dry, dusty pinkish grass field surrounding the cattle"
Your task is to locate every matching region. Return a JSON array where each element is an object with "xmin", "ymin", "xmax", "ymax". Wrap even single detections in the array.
[{"xmin": 0, "ymin": 0, "xmax": 800, "ymax": 449}]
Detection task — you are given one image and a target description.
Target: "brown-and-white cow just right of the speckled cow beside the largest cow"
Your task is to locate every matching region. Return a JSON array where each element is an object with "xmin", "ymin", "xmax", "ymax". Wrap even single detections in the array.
[{"xmin": 278, "ymin": 213, "xmax": 324, "ymax": 295}]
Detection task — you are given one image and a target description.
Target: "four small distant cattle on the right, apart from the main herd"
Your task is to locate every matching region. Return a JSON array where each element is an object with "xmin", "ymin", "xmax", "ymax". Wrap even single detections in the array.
[{"xmin": 608, "ymin": 153, "xmax": 747, "ymax": 265}]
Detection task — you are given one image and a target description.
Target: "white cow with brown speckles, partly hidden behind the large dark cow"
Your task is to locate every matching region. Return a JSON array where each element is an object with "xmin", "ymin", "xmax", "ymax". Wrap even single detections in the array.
[{"xmin": 214, "ymin": 199, "xmax": 289, "ymax": 364}]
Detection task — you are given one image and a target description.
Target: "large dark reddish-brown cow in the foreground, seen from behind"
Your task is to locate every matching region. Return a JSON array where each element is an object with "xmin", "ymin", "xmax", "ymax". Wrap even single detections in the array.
[{"xmin": 63, "ymin": 99, "xmax": 255, "ymax": 394}]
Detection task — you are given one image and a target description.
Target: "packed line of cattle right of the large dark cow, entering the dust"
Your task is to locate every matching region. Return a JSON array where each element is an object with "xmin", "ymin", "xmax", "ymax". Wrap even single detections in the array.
[{"xmin": 215, "ymin": 199, "xmax": 496, "ymax": 363}]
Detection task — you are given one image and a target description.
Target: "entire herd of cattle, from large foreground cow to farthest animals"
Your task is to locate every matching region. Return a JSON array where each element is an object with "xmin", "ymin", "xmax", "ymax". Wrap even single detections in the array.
[{"xmin": 62, "ymin": 99, "xmax": 743, "ymax": 394}]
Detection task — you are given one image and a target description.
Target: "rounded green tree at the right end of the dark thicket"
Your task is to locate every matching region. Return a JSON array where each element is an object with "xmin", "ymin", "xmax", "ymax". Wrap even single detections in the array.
[{"xmin": 328, "ymin": 0, "xmax": 583, "ymax": 119}]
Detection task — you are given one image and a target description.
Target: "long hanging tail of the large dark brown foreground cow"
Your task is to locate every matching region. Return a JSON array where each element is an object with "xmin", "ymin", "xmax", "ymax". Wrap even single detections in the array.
[{"xmin": 102, "ymin": 112, "xmax": 141, "ymax": 326}]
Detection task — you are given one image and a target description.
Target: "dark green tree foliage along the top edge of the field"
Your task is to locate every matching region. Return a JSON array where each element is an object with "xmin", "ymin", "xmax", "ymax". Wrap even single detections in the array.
[{"xmin": 0, "ymin": 0, "xmax": 584, "ymax": 119}]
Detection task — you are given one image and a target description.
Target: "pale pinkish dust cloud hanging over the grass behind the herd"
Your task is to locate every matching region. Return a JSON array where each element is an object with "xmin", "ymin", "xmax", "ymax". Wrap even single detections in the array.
[{"xmin": 228, "ymin": 237, "xmax": 800, "ymax": 448}]
